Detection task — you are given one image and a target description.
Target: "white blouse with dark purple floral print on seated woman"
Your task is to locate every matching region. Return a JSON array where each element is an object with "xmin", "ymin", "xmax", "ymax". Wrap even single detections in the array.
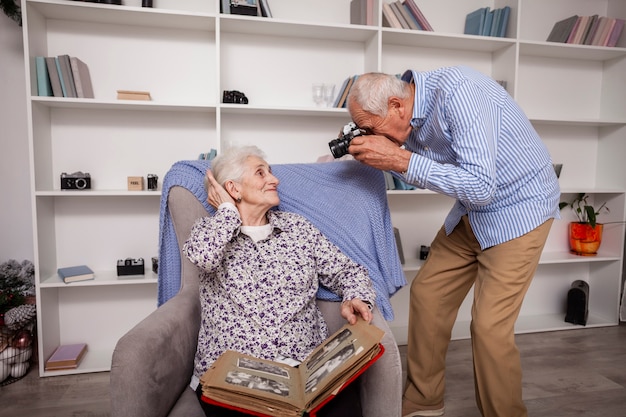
[{"xmin": 183, "ymin": 207, "xmax": 375, "ymax": 378}]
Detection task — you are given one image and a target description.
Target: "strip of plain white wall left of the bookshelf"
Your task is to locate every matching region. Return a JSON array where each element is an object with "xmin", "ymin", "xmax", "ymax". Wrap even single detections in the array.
[{"xmin": 0, "ymin": 13, "xmax": 34, "ymax": 263}]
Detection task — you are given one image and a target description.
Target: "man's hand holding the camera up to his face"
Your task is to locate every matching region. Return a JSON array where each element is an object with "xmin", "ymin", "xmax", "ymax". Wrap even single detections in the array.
[{"xmin": 348, "ymin": 135, "xmax": 411, "ymax": 172}]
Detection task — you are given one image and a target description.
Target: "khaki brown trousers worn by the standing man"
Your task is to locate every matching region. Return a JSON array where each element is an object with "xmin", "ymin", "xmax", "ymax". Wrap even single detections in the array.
[{"xmin": 404, "ymin": 216, "xmax": 552, "ymax": 417}]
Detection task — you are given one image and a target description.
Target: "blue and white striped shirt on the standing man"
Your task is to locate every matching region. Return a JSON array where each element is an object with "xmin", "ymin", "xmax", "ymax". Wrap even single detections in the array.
[{"xmin": 402, "ymin": 67, "xmax": 560, "ymax": 249}]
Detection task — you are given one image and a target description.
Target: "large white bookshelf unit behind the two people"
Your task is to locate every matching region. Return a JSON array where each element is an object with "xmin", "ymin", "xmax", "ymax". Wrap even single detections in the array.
[{"xmin": 22, "ymin": 0, "xmax": 626, "ymax": 376}]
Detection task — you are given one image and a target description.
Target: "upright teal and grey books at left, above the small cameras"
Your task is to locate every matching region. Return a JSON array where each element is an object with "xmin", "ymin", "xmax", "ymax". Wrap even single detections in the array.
[{"xmin": 35, "ymin": 55, "xmax": 94, "ymax": 98}]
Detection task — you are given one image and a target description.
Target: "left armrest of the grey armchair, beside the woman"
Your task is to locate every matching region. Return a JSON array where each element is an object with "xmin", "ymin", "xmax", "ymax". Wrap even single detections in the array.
[{"xmin": 110, "ymin": 286, "xmax": 200, "ymax": 417}]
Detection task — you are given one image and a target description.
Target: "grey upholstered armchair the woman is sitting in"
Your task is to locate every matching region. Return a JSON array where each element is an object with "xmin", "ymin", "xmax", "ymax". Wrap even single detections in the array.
[{"xmin": 110, "ymin": 162, "xmax": 403, "ymax": 417}]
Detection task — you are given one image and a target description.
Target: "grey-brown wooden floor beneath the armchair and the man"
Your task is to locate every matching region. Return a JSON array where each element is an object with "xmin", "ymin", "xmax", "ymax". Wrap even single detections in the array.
[{"xmin": 0, "ymin": 324, "xmax": 626, "ymax": 417}]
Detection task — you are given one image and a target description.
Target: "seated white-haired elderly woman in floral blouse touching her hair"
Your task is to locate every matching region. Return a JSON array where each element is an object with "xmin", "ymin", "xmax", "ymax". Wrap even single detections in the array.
[{"xmin": 183, "ymin": 146, "xmax": 375, "ymax": 416}]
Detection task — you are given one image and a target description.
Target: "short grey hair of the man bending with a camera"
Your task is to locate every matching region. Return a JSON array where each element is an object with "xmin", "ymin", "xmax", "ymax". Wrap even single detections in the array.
[{"xmin": 348, "ymin": 72, "xmax": 411, "ymax": 117}]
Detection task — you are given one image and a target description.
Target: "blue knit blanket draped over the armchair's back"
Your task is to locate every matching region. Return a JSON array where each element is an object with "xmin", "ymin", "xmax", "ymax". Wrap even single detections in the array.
[{"xmin": 158, "ymin": 161, "xmax": 406, "ymax": 320}]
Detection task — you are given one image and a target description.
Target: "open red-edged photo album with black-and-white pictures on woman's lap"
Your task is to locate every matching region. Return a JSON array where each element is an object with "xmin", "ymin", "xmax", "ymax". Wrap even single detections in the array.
[{"xmin": 200, "ymin": 319, "xmax": 384, "ymax": 417}]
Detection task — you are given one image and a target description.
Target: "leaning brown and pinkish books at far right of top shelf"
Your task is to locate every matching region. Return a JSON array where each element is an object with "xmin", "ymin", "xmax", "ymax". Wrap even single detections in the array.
[{"xmin": 547, "ymin": 14, "xmax": 624, "ymax": 46}]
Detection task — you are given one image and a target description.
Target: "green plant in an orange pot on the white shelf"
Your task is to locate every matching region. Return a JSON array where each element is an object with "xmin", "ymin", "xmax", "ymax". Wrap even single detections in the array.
[{"xmin": 559, "ymin": 193, "xmax": 609, "ymax": 256}]
